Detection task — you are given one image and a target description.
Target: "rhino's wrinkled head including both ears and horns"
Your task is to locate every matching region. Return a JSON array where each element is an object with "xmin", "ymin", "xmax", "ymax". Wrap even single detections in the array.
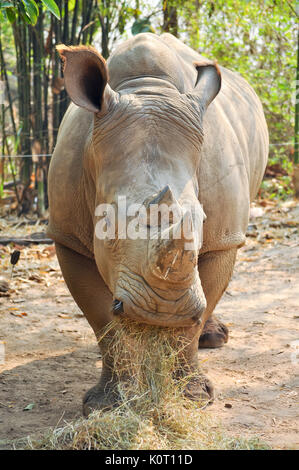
[{"xmin": 58, "ymin": 45, "xmax": 221, "ymax": 327}]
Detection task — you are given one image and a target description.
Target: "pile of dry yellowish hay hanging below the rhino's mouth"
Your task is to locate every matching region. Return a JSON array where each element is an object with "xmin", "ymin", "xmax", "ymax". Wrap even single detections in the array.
[{"xmin": 27, "ymin": 320, "xmax": 268, "ymax": 450}]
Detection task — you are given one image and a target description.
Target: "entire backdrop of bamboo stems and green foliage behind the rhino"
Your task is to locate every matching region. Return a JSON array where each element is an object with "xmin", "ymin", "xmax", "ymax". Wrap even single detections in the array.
[{"xmin": 0, "ymin": 0, "xmax": 298, "ymax": 215}]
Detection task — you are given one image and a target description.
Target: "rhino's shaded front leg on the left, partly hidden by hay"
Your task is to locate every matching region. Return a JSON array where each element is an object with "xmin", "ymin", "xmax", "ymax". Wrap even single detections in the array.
[{"xmin": 56, "ymin": 243, "xmax": 117, "ymax": 416}]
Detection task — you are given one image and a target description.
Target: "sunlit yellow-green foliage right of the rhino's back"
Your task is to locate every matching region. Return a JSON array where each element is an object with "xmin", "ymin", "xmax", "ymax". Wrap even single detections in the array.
[{"xmin": 168, "ymin": 0, "xmax": 298, "ymax": 197}]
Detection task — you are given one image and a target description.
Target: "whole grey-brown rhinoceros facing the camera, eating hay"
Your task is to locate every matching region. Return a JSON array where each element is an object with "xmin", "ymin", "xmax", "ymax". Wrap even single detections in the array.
[{"xmin": 48, "ymin": 33, "xmax": 268, "ymax": 415}]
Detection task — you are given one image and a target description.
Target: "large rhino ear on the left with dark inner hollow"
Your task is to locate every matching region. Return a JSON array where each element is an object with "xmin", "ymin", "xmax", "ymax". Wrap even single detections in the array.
[{"xmin": 56, "ymin": 44, "xmax": 114, "ymax": 113}]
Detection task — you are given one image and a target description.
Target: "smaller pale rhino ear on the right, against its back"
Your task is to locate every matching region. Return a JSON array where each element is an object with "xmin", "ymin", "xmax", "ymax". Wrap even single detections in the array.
[{"xmin": 192, "ymin": 59, "xmax": 221, "ymax": 110}]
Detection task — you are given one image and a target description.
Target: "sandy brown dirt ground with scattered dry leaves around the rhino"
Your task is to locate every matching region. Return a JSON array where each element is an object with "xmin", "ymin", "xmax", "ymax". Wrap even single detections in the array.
[{"xmin": 0, "ymin": 201, "xmax": 299, "ymax": 449}]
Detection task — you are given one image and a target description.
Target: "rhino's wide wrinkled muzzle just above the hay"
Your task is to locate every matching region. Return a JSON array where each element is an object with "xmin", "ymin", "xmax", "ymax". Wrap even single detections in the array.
[{"xmin": 112, "ymin": 274, "xmax": 206, "ymax": 327}]
